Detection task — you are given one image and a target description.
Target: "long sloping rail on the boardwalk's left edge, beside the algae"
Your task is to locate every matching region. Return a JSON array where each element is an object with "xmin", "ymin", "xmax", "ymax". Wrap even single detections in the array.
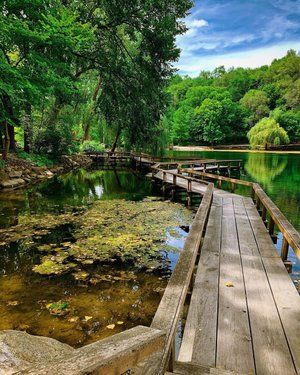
[{"xmin": 151, "ymin": 183, "xmax": 213, "ymax": 375}]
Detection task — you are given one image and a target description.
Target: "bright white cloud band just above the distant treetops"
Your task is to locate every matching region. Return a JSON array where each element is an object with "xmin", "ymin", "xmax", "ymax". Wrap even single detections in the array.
[{"xmin": 176, "ymin": 41, "xmax": 300, "ymax": 76}]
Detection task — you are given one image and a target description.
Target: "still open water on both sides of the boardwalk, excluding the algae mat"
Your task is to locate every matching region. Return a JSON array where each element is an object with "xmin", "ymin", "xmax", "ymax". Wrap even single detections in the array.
[{"xmin": 0, "ymin": 151, "xmax": 300, "ymax": 347}]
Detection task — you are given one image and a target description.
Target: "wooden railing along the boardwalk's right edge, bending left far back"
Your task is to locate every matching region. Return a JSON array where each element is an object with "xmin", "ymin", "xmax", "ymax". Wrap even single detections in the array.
[{"xmin": 181, "ymin": 169, "xmax": 300, "ymax": 261}]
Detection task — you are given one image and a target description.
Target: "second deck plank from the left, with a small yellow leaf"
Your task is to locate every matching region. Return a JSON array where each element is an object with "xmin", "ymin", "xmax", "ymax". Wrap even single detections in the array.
[{"xmin": 217, "ymin": 198, "xmax": 255, "ymax": 374}]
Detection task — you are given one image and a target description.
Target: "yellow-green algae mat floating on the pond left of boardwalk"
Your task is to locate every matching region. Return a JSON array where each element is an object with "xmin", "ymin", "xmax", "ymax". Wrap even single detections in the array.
[{"xmin": 0, "ymin": 198, "xmax": 192, "ymax": 282}]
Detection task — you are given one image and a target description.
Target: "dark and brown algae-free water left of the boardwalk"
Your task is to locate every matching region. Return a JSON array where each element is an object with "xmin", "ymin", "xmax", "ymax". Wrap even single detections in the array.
[{"xmin": 0, "ymin": 169, "xmax": 190, "ymax": 347}]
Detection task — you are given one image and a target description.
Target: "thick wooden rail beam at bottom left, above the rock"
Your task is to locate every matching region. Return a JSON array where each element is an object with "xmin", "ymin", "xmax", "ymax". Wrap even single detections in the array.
[{"xmin": 18, "ymin": 326, "xmax": 166, "ymax": 375}]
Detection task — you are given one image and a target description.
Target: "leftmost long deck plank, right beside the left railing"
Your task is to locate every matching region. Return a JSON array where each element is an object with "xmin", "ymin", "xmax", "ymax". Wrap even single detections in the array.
[{"xmin": 178, "ymin": 198, "xmax": 222, "ymax": 366}]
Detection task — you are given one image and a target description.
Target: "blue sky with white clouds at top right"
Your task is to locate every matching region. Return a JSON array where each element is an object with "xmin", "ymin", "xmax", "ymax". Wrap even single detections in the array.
[{"xmin": 176, "ymin": 0, "xmax": 300, "ymax": 76}]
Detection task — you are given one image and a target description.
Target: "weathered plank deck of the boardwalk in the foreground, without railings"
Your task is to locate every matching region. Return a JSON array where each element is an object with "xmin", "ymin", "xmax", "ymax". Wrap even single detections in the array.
[{"xmin": 178, "ymin": 194, "xmax": 300, "ymax": 375}]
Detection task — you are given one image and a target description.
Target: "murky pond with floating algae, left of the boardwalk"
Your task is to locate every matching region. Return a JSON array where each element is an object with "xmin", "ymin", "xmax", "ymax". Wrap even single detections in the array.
[{"xmin": 0, "ymin": 169, "xmax": 193, "ymax": 347}]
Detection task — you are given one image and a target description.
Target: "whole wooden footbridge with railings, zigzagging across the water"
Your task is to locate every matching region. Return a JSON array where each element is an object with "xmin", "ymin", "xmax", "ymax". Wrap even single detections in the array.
[{"xmin": 25, "ymin": 151, "xmax": 300, "ymax": 375}]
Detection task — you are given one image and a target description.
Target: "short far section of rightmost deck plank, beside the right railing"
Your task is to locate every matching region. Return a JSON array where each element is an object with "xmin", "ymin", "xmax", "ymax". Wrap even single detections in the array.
[{"xmin": 243, "ymin": 198, "xmax": 279, "ymax": 258}]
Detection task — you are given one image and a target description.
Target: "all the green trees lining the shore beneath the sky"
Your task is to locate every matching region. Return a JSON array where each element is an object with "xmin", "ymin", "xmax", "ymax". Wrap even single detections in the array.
[{"xmin": 0, "ymin": 0, "xmax": 300, "ymax": 164}]
